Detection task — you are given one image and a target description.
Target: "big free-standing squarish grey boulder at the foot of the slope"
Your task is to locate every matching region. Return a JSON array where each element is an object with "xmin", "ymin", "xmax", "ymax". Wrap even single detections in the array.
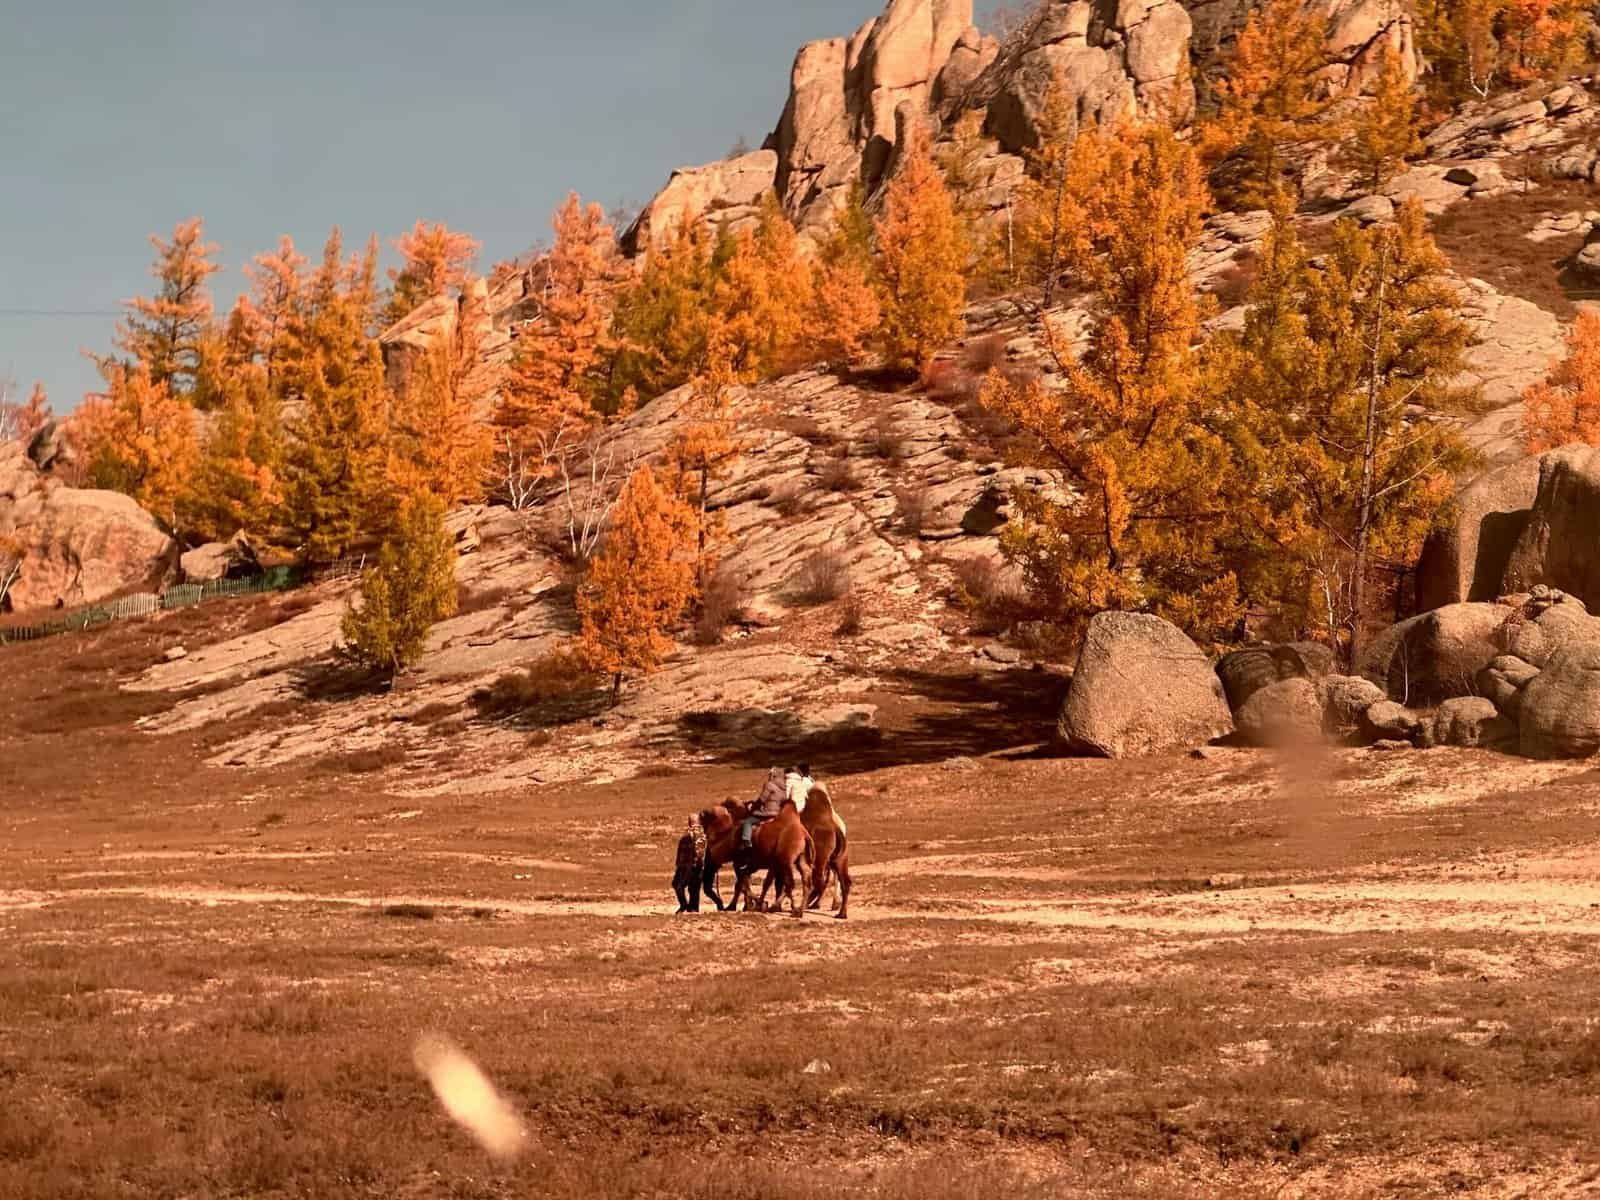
[{"xmin": 1059, "ymin": 613, "xmax": 1234, "ymax": 758}]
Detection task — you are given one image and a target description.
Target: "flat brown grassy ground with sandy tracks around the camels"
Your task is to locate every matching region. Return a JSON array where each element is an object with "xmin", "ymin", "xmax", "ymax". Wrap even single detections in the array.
[{"xmin": 0, "ymin": 614, "xmax": 1600, "ymax": 1200}]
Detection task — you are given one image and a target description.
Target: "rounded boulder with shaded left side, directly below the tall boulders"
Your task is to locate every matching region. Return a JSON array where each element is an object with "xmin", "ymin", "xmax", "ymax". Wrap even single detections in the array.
[{"xmin": 1360, "ymin": 603, "xmax": 1515, "ymax": 706}]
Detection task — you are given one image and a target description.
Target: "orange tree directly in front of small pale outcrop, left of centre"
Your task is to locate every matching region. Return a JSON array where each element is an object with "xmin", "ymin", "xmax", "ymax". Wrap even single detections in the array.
[{"xmin": 389, "ymin": 283, "xmax": 493, "ymax": 506}]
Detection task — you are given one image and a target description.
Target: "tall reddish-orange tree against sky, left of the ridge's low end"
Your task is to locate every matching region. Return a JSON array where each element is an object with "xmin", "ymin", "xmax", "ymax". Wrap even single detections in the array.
[{"xmin": 493, "ymin": 192, "xmax": 619, "ymax": 492}]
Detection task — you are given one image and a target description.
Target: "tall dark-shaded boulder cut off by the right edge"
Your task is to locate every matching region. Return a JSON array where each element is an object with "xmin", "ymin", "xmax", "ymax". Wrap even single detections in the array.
[{"xmin": 1504, "ymin": 446, "xmax": 1600, "ymax": 608}]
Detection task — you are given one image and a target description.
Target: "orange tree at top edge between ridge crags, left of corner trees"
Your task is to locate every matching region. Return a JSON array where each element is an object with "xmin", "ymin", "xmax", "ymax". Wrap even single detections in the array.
[{"xmin": 1200, "ymin": 0, "xmax": 1338, "ymax": 208}]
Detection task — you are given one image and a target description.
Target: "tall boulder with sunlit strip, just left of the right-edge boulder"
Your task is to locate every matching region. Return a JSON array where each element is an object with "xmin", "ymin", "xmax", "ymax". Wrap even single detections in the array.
[{"xmin": 1416, "ymin": 458, "xmax": 1539, "ymax": 611}]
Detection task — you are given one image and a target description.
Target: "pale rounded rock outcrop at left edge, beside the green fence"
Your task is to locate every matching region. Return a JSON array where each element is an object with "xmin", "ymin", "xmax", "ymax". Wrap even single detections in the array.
[{"xmin": 0, "ymin": 442, "xmax": 174, "ymax": 613}]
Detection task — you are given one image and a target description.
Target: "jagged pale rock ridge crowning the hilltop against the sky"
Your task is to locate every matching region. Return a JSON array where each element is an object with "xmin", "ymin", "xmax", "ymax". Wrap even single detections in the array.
[{"xmin": 624, "ymin": 0, "xmax": 1418, "ymax": 254}]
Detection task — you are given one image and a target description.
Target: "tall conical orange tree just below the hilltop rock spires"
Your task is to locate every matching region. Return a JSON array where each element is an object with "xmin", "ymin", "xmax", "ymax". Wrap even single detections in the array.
[{"xmin": 875, "ymin": 136, "xmax": 968, "ymax": 371}]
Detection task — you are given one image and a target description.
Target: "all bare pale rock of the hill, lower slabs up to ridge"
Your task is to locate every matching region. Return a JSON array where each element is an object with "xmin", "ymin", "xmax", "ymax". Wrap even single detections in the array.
[{"xmin": 9, "ymin": 0, "xmax": 1600, "ymax": 790}]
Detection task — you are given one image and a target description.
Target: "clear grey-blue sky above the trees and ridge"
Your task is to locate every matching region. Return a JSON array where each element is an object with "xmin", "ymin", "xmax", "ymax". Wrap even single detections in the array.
[{"xmin": 0, "ymin": 0, "xmax": 934, "ymax": 411}]
